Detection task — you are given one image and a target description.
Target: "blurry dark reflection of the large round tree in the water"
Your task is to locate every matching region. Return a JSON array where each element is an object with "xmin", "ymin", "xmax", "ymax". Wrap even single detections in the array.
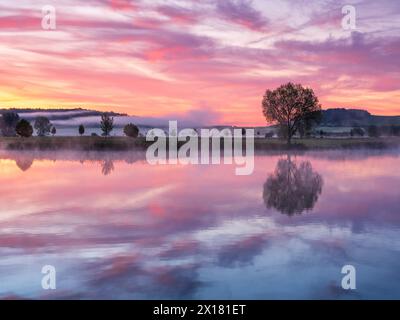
[{"xmin": 263, "ymin": 155, "xmax": 323, "ymax": 216}]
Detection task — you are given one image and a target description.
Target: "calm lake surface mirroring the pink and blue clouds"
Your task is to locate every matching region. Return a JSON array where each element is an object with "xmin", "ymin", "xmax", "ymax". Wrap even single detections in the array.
[{"xmin": 0, "ymin": 151, "xmax": 400, "ymax": 299}]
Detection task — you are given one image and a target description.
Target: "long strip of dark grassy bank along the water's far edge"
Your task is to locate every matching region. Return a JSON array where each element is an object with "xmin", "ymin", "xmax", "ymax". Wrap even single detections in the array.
[{"xmin": 0, "ymin": 137, "xmax": 400, "ymax": 151}]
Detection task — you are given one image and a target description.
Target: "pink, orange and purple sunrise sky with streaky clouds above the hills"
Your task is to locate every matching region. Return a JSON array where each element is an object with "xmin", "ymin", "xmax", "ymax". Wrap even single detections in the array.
[{"xmin": 0, "ymin": 0, "xmax": 400, "ymax": 125}]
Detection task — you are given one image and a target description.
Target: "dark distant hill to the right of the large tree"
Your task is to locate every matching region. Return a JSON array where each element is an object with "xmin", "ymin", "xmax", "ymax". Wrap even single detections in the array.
[{"xmin": 321, "ymin": 108, "xmax": 400, "ymax": 127}]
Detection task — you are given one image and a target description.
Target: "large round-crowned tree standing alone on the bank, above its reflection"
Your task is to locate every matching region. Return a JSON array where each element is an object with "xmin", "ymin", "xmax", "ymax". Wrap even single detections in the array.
[{"xmin": 262, "ymin": 82, "xmax": 321, "ymax": 144}]
